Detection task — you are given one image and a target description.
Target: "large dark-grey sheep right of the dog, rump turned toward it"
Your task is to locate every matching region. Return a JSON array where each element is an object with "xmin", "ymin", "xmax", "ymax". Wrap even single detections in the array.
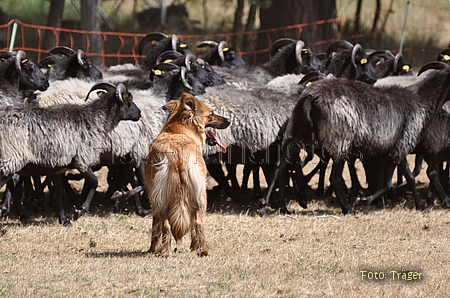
[{"xmin": 261, "ymin": 67, "xmax": 450, "ymax": 214}]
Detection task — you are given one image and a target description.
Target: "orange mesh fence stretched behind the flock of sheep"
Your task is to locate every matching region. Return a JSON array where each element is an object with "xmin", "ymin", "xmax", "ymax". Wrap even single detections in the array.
[{"xmin": 0, "ymin": 11, "xmax": 442, "ymax": 66}]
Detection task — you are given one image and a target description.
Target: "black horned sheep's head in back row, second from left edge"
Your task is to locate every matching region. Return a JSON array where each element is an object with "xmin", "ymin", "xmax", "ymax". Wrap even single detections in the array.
[{"xmin": 39, "ymin": 46, "xmax": 103, "ymax": 81}]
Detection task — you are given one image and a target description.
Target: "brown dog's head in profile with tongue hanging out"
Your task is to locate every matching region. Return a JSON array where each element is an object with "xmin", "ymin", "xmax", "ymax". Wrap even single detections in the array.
[{"xmin": 165, "ymin": 93, "xmax": 231, "ymax": 153}]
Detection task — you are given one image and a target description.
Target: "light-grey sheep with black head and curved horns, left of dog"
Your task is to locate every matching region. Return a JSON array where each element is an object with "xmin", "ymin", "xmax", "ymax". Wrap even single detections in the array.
[{"xmin": 0, "ymin": 83, "xmax": 141, "ymax": 224}]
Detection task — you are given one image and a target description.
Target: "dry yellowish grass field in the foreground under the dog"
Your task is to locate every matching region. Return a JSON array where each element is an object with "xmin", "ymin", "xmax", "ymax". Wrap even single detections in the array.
[{"xmin": 0, "ymin": 156, "xmax": 450, "ymax": 297}]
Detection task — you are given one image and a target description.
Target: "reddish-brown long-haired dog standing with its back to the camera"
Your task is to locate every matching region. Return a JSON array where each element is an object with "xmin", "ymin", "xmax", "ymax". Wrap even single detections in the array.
[{"xmin": 146, "ymin": 93, "xmax": 230, "ymax": 256}]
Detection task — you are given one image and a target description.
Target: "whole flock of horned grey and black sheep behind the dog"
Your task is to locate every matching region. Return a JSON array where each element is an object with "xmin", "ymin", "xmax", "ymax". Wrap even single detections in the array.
[{"xmin": 0, "ymin": 33, "xmax": 450, "ymax": 225}]
